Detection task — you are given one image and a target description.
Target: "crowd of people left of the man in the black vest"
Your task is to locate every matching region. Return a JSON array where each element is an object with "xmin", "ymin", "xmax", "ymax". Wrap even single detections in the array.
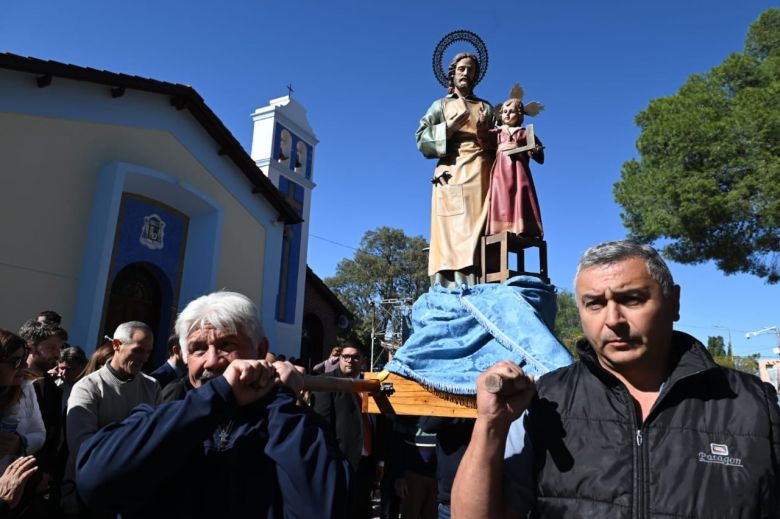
[{"xmin": 0, "ymin": 292, "xmax": 454, "ymax": 518}]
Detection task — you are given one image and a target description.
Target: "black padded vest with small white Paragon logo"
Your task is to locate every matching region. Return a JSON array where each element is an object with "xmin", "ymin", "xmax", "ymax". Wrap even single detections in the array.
[{"xmin": 526, "ymin": 332, "xmax": 780, "ymax": 519}]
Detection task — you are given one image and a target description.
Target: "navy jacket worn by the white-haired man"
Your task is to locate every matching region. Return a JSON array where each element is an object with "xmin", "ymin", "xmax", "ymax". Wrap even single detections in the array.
[{"xmin": 76, "ymin": 377, "xmax": 351, "ymax": 518}]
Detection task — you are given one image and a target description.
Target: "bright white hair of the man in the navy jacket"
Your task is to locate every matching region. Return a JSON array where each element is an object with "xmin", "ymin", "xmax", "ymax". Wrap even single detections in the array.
[{"xmin": 176, "ymin": 292, "xmax": 265, "ymax": 363}]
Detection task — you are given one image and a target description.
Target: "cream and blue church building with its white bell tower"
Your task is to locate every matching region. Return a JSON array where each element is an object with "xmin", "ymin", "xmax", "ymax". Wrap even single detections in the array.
[{"xmin": 0, "ymin": 53, "xmax": 342, "ymax": 364}]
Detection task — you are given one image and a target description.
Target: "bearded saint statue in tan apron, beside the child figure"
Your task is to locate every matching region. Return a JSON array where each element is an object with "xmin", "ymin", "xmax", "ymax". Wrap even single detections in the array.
[{"xmin": 416, "ymin": 53, "xmax": 494, "ymax": 286}]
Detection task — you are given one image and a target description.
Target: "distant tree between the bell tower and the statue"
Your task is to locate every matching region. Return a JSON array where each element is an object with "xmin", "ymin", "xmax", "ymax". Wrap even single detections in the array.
[{"xmin": 325, "ymin": 227, "xmax": 430, "ymax": 345}]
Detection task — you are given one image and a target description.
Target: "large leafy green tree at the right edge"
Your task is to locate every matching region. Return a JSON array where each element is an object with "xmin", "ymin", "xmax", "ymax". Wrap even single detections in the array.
[{"xmin": 614, "ymin": 9, "xmax": 780, "ymax": 283}]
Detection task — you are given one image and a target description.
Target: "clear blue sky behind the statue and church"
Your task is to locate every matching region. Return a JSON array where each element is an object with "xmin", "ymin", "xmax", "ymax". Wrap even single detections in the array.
[{"xmin": 0, "ymin": 0, "xmax": 780, "ymax": 357}]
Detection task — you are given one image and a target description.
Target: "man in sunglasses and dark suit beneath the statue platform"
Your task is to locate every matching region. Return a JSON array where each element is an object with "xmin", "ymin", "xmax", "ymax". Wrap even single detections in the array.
[{"xmin": 312, "ymin": 343, "xmax": 384, "ymax": 519}]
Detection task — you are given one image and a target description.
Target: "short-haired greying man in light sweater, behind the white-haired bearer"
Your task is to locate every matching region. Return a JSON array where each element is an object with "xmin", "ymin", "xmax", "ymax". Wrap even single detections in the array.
[{"xmin": 63, "ymin": 321, "xmax": 160, "ymax": 511}]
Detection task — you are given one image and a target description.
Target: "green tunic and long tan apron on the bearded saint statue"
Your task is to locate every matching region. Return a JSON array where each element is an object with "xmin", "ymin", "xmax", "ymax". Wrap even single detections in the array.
[{"xmin": 416, "ymin": 94, "xmax": 493, "ymax": 276}]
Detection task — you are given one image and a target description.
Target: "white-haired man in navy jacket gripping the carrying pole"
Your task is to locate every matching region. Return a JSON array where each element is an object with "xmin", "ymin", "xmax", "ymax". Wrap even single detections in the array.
[{"xmin": 77, "ymin": 292, "xmax": 350, "ymax": 518}]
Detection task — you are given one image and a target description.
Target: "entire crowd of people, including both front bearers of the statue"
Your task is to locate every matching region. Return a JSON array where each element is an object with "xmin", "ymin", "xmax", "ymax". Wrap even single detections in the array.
[{"xmin": 0, "ymin": 241, "xmax": 780, "ymax": 519}]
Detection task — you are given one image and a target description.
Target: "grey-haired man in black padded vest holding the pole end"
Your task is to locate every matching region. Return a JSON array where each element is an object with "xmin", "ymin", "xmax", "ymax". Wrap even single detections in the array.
[{"xmin": 452, "ymin": 241, "xmax": 780, "ymax": 518}]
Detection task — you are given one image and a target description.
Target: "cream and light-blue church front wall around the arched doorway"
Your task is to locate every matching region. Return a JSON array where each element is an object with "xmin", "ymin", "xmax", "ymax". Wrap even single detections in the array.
[{"xmin": 0, "ymin": 71, "xmax": 282, "ymax": 350}]
